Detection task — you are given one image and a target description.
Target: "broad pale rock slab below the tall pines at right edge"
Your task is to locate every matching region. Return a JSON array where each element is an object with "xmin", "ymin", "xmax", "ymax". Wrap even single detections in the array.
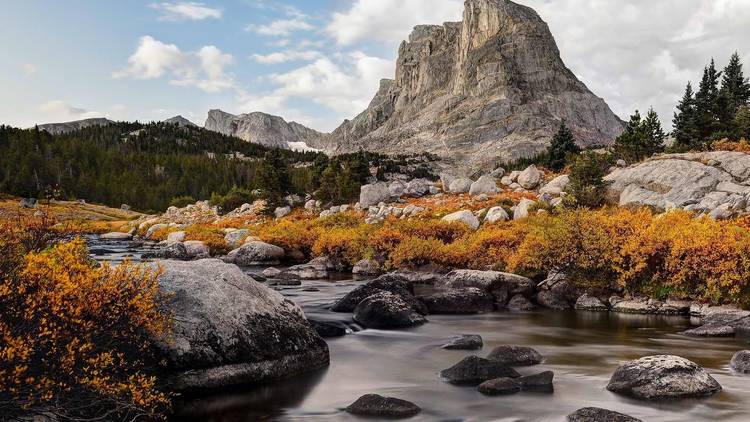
[{"xmin": 605, "ymin": 151, "xmax": 750, "ymax": 218}]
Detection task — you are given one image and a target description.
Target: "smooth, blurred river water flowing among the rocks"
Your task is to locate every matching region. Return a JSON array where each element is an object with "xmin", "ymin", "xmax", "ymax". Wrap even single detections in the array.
[{"xmin": 92, "ymin": 242, "xmax": 750, "ymax": 422}]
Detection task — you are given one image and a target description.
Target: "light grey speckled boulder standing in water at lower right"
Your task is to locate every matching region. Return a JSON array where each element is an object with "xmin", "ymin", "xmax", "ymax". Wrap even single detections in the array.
[{"xmin": 607, "ymin": 355, "xmax": 721, "ymax": 400}]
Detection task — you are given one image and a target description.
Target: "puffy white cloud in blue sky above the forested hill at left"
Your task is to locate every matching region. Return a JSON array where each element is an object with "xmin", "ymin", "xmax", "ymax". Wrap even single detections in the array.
[{"xmin": 112, "ymin": 35, "xmax": 235, "ymax": 92}]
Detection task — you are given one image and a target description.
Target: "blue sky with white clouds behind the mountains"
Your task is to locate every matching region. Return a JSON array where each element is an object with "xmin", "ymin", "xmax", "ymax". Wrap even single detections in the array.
[{"xmin": 0, "ymin": 0, "xmax": 750, "ymax": 131}]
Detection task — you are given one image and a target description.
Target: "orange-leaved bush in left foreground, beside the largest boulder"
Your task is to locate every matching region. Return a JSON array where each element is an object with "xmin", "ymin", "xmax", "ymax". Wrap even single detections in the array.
[{"xmin": 0, "ymin": 216, "xmax": 171, "ymax": 420}]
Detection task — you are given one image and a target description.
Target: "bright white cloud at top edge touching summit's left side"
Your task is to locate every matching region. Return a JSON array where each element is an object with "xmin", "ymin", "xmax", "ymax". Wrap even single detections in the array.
[{"xmin": 326, "ymin": 0, "xmax": 463, "ymax": 45}]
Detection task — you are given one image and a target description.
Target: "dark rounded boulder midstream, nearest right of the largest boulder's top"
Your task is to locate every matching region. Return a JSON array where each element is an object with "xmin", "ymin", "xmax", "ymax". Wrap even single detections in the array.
[{"xmin": 354, "ymin": 292, "xmax": 427, "ymax": 328}]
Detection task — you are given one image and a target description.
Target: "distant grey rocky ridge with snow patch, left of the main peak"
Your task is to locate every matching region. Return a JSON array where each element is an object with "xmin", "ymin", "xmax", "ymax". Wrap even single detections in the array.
[{"xmin": 205, "ymin": 110, "xmax": 323, "ymax": 149}]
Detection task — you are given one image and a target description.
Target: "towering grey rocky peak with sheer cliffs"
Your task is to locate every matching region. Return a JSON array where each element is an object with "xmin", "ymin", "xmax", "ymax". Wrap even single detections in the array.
[{"xmin": 325, "ymin": 0, "xmax": 622, "ymax": 166}]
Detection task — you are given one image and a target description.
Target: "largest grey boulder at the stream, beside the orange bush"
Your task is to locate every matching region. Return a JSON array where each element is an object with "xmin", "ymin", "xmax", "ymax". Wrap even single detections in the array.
[{"xmin": 151, "ymin": 259, "xmax": 329, "ymax": 391}]
